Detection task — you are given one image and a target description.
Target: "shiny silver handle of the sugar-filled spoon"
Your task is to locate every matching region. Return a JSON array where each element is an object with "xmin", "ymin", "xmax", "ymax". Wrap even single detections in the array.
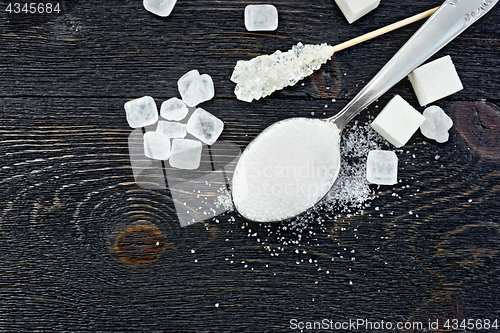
[{"xmin": 328, "ymin": 0, "xmax": 499, "ymax": 129}]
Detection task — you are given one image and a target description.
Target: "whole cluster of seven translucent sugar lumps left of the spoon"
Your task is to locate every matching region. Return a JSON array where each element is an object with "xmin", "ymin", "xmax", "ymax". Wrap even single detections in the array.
[{"xmin": 124, "ymin": 70, "xmax": 224, "ymax": 170}]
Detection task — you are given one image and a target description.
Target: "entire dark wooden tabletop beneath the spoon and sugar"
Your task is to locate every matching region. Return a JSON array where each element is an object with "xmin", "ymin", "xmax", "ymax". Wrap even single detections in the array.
[{"xmin": 0, "ymin": 0, "xmax": 500, "ymax": 332}]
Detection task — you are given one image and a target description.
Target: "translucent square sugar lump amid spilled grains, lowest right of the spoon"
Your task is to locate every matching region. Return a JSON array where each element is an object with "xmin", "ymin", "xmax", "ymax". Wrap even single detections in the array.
[{"xmin": 366, "ymin": 150, "xmax": 398, "ymax": 185}]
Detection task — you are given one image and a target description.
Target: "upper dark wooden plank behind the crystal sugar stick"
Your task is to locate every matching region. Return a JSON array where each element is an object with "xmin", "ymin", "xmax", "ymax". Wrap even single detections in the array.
[{"xmin": 0, "ymin": 1, "xmax": 500, "ymax": 99}]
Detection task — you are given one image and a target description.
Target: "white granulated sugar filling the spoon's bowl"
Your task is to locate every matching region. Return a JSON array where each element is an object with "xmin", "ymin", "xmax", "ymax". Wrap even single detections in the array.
[{"xmin": 233, "ymin": 118, "xmax": 340, "ymax": 222}]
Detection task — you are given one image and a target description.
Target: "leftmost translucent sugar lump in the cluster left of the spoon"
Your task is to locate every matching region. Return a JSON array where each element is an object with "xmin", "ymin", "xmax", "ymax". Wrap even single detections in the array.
[{"xmin": 124, "ymin": 96, "xmax": 158, "ymax": 128}]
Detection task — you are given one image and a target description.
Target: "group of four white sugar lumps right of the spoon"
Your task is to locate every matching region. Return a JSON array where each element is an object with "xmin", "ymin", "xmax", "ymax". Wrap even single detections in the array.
[{"xmin": 366, "ymin": 56, "xmax": 463, "ymax": 185}]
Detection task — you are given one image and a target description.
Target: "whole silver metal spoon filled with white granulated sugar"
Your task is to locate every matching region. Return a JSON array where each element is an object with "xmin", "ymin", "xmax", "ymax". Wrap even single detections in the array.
[{"xmin": 232, "ymin": 0, "xmax": 498, "ymax": 222}]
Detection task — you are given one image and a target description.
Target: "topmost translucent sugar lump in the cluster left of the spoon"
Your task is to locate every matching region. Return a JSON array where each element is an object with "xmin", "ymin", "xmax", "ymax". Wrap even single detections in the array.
[{"xmin": 177, "ymin": 69, "xmax": 215, "ymax": 106}]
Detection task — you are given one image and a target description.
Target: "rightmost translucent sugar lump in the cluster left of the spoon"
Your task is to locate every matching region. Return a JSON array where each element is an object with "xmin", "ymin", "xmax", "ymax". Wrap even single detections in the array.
[{"xmin": 187, "ymin": 108, "xmax": 224, "ymax": 145}]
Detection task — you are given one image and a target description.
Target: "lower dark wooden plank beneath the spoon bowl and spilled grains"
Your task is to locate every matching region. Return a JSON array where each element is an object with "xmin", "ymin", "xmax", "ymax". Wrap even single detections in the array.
[{"xmin": 0, "ymin": 98, "xmax": 500, "ymax": 332}]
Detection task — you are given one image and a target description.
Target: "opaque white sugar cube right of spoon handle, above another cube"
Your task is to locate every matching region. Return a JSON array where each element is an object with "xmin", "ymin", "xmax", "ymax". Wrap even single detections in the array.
[{"xmin": 408, "ymin": 56, "xmax": 464, "ymax": 106}]
